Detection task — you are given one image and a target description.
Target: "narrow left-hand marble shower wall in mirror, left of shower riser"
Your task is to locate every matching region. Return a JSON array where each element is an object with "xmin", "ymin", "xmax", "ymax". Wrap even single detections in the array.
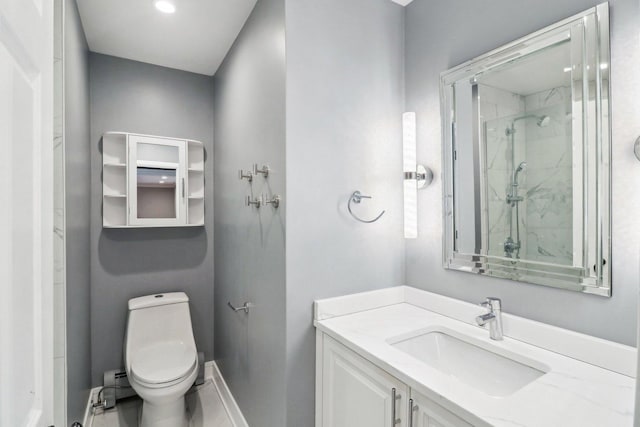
[{"xmin": 478, "ymin": 85, "xmax": 526, "ymax": 256}]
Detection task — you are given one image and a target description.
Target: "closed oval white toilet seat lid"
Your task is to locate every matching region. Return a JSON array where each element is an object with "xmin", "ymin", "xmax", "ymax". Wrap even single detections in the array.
[{"xmin": 131, "ymin": 341, "xmax": 196, "ymax": 384}]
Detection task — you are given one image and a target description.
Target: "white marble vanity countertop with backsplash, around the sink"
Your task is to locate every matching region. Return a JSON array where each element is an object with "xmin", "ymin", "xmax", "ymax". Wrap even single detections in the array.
[{"xmin": 314, "ymin": 287, "xmax": 635, "ymax": 427}]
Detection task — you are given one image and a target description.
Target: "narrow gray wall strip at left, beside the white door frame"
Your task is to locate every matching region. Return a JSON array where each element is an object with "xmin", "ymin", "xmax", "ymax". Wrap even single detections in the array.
[{"xmin": 63, "ymin": 0, "xmax": 91, "ymax": 424}]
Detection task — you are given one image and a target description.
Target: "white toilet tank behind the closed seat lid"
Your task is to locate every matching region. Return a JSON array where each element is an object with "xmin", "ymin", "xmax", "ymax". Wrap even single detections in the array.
[{"xmin": 124, "ymin": 292, "xmax": 196, "ymax": 366}]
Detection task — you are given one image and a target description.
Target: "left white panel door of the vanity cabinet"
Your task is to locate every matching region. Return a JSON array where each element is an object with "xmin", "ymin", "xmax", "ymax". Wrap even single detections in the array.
[{"xmin": 322, "ymin": 335, "xmax": 408, "ymax": 427}]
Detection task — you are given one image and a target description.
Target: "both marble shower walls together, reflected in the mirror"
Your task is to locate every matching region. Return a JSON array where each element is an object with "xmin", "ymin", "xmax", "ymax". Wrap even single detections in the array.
[{"xmin": 478, "ymin": 85, "xmax": 573, "ymax": 265}]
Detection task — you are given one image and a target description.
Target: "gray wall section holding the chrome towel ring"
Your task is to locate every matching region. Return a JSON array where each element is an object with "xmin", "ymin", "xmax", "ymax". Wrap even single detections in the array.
[{"xmin": 286, "ymin": 0, "xmax": 404, "ymax": 426}]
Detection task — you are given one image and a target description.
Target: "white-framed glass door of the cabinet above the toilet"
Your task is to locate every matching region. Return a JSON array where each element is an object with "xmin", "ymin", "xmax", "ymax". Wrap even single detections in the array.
[{"xmin": 129, "ymin": 135, "xmax": 186, "ymax": 226}]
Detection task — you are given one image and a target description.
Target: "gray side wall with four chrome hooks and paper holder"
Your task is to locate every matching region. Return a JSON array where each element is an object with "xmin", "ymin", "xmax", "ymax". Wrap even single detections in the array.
[{"xmin": 214, "ymin": 0, "xmax": 288, "ymax": 427}]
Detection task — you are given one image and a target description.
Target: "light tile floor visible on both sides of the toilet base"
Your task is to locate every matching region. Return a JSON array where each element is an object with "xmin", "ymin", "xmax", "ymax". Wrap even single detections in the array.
[{"xmin": 87, "ymin": 377, "xmax": 235, "ymax": 427}]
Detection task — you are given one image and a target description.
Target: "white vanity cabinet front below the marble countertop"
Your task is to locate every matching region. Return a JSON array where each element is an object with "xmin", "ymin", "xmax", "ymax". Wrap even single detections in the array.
[{"xmin": 316, "ymin": 332, "xmax": 471, "ymax": 427}]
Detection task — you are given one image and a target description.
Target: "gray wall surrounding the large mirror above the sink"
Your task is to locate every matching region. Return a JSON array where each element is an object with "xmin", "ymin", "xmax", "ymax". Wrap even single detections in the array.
[{"xmin": 405, "ymin": 0, "xmax": 640, "ymax": 345}]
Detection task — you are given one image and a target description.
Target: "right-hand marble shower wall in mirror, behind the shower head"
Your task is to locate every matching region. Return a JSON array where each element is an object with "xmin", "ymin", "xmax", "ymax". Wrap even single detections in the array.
[{"xmin": 523, "ymin": 87, "xmax": 573, "ymax": 265}]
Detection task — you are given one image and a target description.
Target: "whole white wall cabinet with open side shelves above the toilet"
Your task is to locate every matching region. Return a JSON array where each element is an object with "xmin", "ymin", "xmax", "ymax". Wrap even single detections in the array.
[{"xmin": 102, "ymin": 132, "xmax": 204, "ymax": 228}]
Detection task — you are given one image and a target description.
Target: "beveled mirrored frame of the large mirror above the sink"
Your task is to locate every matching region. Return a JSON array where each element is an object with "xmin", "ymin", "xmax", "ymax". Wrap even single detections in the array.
[{"xmin": 440, "ymin": 3, "xmax": 612, "ymax": 296}]
